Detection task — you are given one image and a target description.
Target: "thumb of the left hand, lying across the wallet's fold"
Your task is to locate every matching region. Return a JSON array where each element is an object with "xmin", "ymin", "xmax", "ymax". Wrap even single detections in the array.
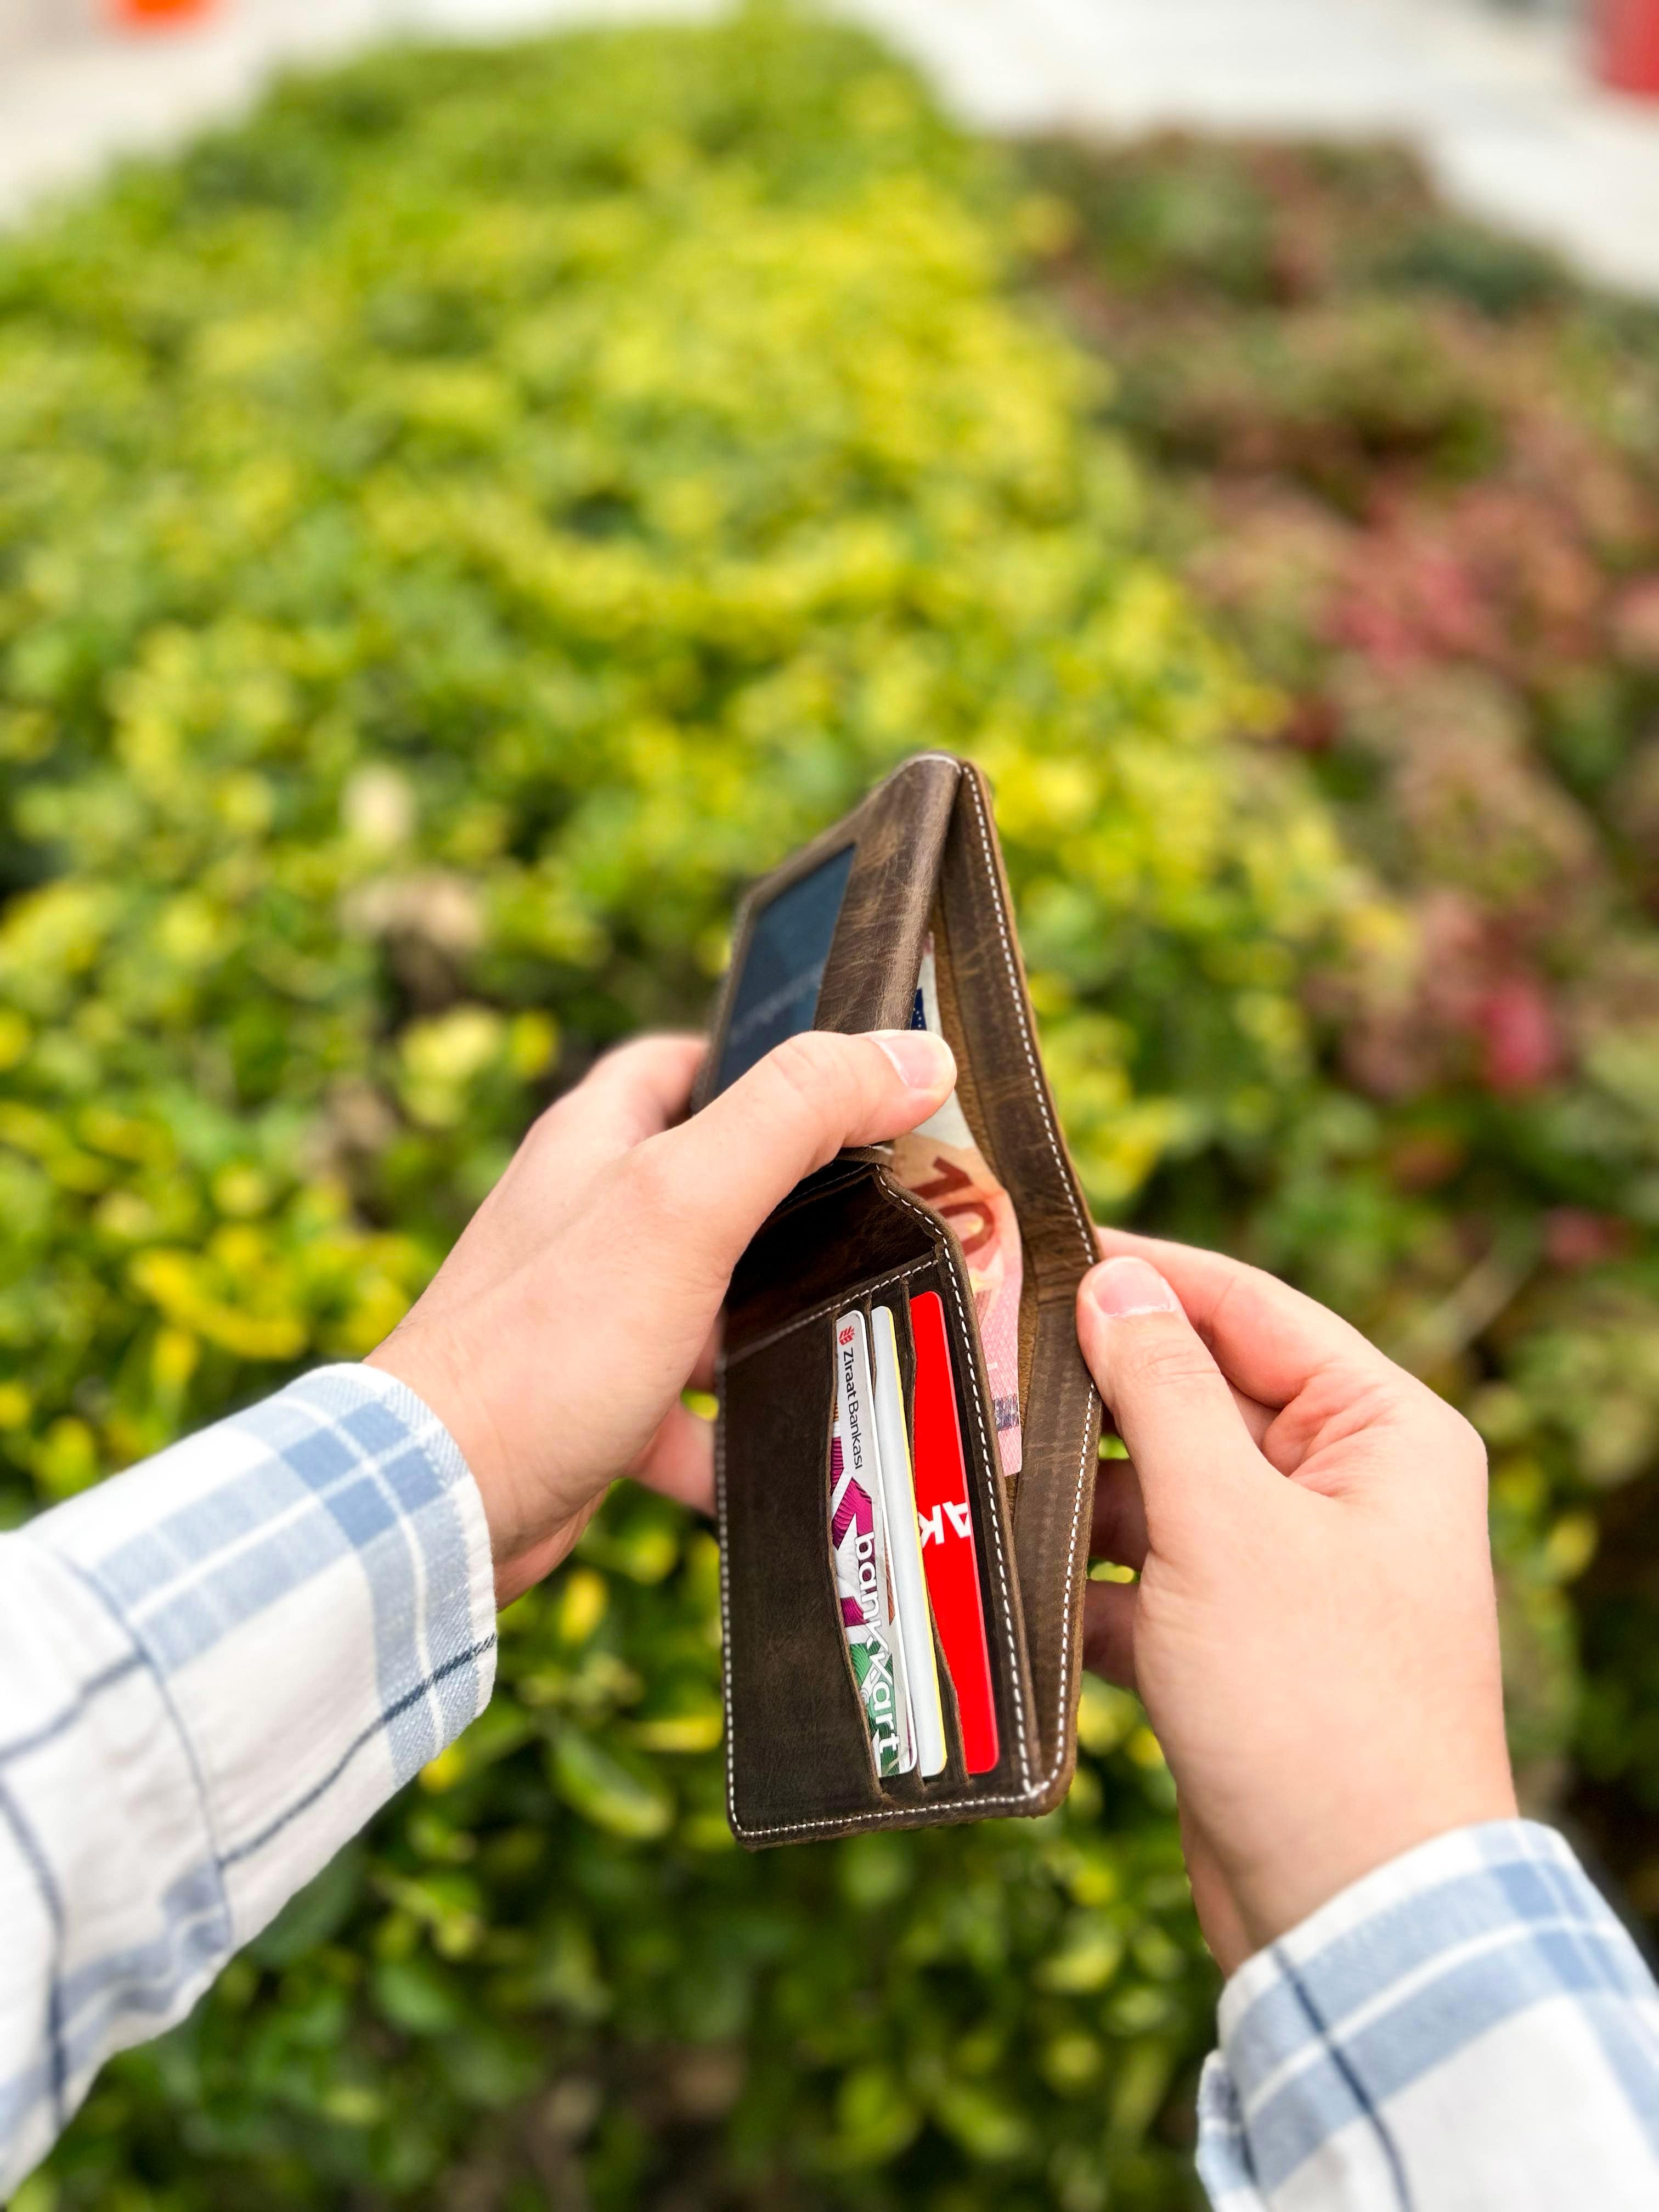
[{"xmin": 635, "ymin": 1029, "xmax": 956, "ymax": 1274}]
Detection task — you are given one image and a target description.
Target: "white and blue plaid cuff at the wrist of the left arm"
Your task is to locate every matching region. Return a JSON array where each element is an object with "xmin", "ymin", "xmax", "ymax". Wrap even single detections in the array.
[{"xmin": 29, "ymin": 1367, "xmax": 495, "ymax": 1944}]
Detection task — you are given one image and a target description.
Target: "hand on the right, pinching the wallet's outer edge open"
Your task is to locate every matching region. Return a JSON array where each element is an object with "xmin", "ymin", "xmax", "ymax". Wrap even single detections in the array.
[{"xmin": 1077, "ymin": 1230, "xmax": 1515, "ymax": 1973}]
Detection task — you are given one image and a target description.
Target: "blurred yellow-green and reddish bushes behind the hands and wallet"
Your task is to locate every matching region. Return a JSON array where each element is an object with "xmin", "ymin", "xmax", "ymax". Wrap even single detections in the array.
[{"xmin": 0, "ymin": 9, "xmax": 1659, "ymax": 2212}]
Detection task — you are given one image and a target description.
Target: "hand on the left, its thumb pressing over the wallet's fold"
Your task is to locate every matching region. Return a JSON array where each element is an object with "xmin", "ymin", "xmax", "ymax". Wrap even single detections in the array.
[{"xmin": 369, "ymin": 1029, "xmax": 956, "ymax": 1606}]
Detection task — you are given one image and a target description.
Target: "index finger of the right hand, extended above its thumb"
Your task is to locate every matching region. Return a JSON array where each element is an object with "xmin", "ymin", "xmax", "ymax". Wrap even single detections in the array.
[{"xmin": 1097, "ymin": 1230, "xmax": 1402, "ymax": 1407}]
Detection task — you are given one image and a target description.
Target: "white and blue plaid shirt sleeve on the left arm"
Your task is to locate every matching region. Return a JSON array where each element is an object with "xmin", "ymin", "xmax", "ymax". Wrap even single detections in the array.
[{"xmin": 0, "ymin": 1367, "xmax": 495, "ymax": 2201}]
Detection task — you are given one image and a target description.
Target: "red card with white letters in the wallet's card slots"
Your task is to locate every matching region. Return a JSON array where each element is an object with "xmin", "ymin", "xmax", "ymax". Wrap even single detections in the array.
[{"xmin": 909, "ymin": 1290, "xmax": 997, "ymax": 1774}]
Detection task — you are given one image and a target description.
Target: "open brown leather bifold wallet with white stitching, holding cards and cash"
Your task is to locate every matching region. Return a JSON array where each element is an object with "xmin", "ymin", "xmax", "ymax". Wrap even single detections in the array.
[{"xmin": 699, "ymin": 752, "xmax": 1099, "ymax": 1847}]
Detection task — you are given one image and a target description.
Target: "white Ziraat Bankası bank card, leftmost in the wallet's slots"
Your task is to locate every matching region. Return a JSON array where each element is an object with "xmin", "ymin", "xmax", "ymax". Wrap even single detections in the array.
[{"xmin": 830, "ymin": 1312, "xmax": 916, "ymax": 1774}]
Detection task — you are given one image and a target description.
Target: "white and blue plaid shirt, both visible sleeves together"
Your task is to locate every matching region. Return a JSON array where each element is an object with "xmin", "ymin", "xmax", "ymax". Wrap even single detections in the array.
[{"xmin": 0, "ymin": 1367, "xmax": 1659, "ymax": 2212}]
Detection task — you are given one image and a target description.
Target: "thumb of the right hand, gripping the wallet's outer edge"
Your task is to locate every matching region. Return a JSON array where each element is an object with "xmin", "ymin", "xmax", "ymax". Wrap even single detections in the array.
[{"xmin": 1077, "ymin": 1259, "xmax": 1265, "ymax": 1544}]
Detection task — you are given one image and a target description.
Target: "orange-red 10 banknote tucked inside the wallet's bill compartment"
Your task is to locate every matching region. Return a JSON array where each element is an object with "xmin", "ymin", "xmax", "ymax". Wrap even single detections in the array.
[{"xmin": 891, "ymin": 936, "xmax": 1024, "ymax": 1475}]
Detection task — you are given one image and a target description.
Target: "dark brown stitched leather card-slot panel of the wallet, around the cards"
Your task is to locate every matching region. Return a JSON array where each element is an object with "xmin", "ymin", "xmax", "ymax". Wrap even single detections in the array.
[{"xmin": 719, "ymin": 1166, "xmax": 1035, "ymax": 1843}]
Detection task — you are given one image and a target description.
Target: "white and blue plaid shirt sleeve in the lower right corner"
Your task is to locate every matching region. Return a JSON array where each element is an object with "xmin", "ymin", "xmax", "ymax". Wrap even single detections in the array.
[{"xmin": 1199, "ymin": 1820, "xmax": 1659, "ymax": 2212}]
